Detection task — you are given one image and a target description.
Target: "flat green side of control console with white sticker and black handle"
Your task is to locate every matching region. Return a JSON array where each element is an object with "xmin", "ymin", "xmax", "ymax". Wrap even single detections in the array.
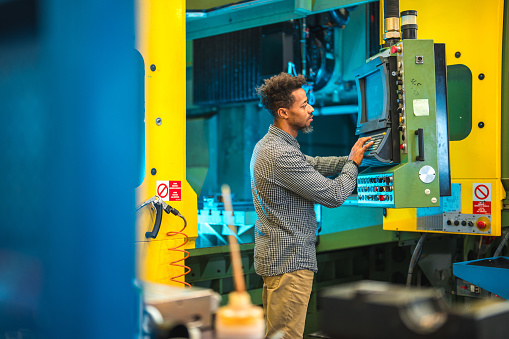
[{"xmin": 392, "ymin": 40, "xmax": 440, "ymax": 208}]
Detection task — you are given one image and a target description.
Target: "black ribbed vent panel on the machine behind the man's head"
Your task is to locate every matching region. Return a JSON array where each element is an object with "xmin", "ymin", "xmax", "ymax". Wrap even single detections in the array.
[{"xmin": 193, "ymin": 22, "xmax": 299, "ymax": 106}]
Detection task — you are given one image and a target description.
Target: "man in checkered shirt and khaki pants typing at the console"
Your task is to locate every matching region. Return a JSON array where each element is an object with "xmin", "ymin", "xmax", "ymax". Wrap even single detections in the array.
[{"xmin": 250, "ymin": 73, "xmax": 373, "ymax": 339}]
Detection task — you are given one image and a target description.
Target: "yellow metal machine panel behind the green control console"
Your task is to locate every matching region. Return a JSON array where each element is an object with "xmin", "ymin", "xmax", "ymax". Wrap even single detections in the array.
[{"xmin": 381, "ymin": 0, "xmax": 505, "ymax": 236}]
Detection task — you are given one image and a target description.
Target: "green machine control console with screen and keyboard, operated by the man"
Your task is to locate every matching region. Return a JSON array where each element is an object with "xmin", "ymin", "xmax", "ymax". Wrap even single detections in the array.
[{"xmin": 355, "ymin": 39, "xmax": 451, "ymax": 208}]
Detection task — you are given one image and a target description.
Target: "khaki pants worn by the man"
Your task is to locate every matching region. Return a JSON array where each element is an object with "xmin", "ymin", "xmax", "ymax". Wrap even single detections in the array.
[{"xmin": 262, "ymin": 270, "xmax": 314, "ymax": 339}]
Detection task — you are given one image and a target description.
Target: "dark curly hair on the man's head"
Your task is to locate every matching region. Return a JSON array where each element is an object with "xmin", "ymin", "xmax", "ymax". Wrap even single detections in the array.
[{"xmin": 256, "ymin": 72, "xmax": 307, "ymax": 118}]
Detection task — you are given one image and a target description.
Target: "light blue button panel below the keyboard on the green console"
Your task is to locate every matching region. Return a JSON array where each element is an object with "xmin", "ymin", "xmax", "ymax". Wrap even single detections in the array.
[{"xmin": 357, "ymin": 173, "xmax": 394, "ymax": 207}]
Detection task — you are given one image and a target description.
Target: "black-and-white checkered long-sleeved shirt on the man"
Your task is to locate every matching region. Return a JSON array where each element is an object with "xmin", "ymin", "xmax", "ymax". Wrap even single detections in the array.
[{"xmin": 250, "ymin": 125, "xmax": 357, "ymax": 276}]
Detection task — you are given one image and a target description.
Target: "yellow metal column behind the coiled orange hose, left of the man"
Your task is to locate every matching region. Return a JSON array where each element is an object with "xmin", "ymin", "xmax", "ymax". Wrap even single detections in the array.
[{"xmin": 136, "ymin": 0, "xmax": 198, "ymax": 286}]
